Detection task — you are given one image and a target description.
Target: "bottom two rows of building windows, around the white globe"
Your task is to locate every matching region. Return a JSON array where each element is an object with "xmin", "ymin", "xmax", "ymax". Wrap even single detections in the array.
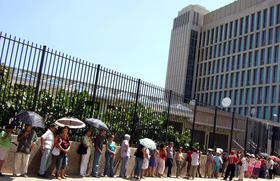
[{"xmin": 197, "ymin": 86, "xmax": 280, "ymax": 120}]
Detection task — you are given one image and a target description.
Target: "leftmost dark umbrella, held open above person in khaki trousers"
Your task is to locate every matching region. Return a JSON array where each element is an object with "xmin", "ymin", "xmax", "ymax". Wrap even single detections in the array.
[{"xmin": 16, "ymin": 111, "xmax": 46, "ymax": 128}]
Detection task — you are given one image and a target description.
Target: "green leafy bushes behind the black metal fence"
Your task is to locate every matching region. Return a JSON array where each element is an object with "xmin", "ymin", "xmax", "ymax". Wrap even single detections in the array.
[{"xmin": 0, "ymin": 64, "xmax": 190, "ymax": 147}]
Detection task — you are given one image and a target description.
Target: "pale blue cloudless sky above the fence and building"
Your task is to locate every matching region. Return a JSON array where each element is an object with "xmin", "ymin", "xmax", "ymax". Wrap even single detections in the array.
[{"xmin": 0, "ymin": 0, "xmax": 234, "ymax": 87}]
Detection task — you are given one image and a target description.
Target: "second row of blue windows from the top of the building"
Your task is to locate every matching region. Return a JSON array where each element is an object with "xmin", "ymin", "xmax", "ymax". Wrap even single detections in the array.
[{"xmin": 200, "ymin": 26, "xmax": 280, "ymax": 61}]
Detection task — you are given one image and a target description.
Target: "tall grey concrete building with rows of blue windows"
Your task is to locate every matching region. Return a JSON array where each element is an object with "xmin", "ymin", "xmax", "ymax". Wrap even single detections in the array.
[{"xmin": 165, "ymin": 0, "xmax": 280, "ymax": 153}]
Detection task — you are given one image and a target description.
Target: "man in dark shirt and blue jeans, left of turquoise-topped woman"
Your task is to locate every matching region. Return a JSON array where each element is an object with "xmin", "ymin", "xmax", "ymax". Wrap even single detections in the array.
[{"xmin": 91, "ymin": 130, "xmax": 106, "ymax": 177}]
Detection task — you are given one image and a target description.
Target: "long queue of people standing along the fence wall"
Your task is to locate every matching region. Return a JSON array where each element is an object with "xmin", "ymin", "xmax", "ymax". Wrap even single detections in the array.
[{"xmin": 0, "ymin": 124, "xmax": 278, "ymax": 181}]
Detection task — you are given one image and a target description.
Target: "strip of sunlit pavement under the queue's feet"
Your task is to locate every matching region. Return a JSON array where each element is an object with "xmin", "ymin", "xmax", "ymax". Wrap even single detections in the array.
[{"xmin": 0, "ymin": 175, "xmax": 280, "ymax": 181}]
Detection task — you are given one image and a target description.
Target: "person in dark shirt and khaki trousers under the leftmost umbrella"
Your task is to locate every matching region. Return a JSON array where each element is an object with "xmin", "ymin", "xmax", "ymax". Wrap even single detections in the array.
[{"xmin": 13, "ymin": 125, "xmax": 37, "ymax": 177}]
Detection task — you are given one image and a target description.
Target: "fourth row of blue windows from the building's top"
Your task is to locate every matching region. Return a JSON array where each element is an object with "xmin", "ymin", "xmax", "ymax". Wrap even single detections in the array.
[{"xmin": 197, "ymin": 65, "xmax": 278, "ymax": 91}]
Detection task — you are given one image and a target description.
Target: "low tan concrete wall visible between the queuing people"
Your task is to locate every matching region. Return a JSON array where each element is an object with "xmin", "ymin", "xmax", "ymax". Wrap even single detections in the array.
[{"xmin": 2, "ymin": 136, "xmax": 206, "ymax": 176}]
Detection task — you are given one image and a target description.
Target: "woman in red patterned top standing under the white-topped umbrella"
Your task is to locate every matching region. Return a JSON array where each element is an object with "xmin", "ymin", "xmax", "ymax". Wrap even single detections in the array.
[{"xmin": 55, "ymin": 126, "xmax": 70, "ymax": 180}]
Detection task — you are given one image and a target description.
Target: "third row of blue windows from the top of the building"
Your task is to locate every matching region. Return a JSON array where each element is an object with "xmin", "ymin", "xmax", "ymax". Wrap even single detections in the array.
[{"xmin": 198, "ymin": 46, "xmax": 280, "ymax": 76}]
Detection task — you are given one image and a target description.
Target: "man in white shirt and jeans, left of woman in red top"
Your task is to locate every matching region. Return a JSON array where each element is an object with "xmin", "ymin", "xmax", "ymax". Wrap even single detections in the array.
[{"xmin": 38, "ymin": 124, "xmax": 56, "ymax": 178}]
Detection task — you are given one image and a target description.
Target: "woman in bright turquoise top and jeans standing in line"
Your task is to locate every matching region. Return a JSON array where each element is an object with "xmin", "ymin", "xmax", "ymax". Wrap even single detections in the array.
[{"xmin": 104, "ymin": 135, "xmax": 117, "ymax": 177}]
